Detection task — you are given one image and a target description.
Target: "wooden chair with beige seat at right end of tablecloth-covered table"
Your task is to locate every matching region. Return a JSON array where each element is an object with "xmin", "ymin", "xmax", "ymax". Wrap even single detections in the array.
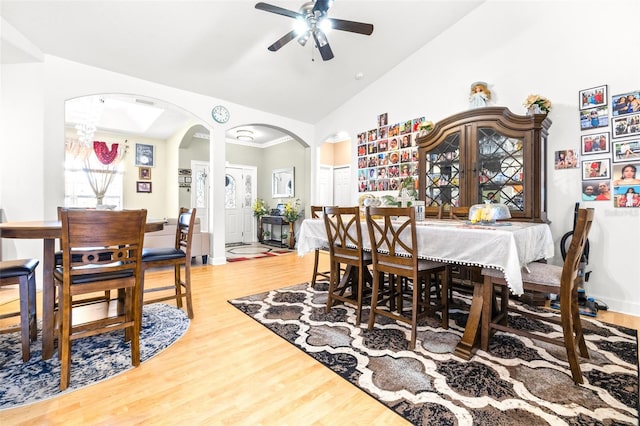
[{"xmin": 481, "ymin": 208, "xmax": 594, "ymax": 384}]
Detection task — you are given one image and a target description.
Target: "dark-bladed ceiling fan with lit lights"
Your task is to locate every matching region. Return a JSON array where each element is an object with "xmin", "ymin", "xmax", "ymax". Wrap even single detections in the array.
[{"xmin": 256, "ymin": 0, "xmax": 373, "ymax": 61}]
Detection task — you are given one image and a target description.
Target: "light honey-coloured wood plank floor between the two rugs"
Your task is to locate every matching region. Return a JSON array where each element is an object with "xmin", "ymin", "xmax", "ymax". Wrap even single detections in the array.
[{"xmin": 0, "ymin": 254, "xmax": 640, "ymax": 426}]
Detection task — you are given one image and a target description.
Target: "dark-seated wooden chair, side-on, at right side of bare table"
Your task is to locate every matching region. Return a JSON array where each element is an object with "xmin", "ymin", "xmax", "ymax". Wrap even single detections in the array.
[{"xmin": 142, "ymin": 207, "xmax": 196, "ymax": 319}]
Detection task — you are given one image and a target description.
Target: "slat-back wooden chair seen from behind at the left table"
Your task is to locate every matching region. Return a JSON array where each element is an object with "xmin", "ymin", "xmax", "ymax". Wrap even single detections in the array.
[{"xmin": 53, "ymin": 209, "xmax": 147, "ymax": 390}]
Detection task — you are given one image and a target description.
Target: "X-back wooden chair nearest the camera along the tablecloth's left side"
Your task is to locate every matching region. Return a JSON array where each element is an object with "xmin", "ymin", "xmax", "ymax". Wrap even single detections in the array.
[{"xmin": 365, "ymin": 207, "xmax": 450, "ymax": 349}]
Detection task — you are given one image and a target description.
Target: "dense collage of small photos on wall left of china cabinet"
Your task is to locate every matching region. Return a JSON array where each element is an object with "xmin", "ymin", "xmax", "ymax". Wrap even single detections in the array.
[{"xmin": 357, "ymin": 113, "xmax": 425, "ymax": 192}]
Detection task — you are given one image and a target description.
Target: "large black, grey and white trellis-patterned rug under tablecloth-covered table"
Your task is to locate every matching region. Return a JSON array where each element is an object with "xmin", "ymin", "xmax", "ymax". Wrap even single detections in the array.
[{"xmin": 229, "ymin": 283, "xmax": 638, "ymax": 425}]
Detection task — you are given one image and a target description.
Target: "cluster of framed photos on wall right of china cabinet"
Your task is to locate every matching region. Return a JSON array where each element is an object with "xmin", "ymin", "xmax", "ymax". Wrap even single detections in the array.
[{"xmin": 576, "ymin": 85, "xmax": 640, "ymax": 208}]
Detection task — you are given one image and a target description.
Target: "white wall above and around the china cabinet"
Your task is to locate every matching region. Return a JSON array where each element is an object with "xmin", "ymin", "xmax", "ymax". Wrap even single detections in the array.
[{"xmin": 316, "ymin": 0, "xmax": 640, "ymax": 315}]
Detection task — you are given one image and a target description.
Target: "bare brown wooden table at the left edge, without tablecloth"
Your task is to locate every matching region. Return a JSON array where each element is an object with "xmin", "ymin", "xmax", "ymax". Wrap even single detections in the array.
[{"xmin": 0, "ymin": 219, "xmax": 165, "ymax": 359}]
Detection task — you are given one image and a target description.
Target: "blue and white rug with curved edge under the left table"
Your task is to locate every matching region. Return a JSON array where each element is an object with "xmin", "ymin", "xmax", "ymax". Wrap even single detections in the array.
[{"xmin": 0, "ymin": 303, "xmax": 190, "ymax": 410}]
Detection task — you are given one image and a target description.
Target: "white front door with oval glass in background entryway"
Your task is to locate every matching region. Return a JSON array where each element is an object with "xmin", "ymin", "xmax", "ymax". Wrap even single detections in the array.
[{"xmin": 225, "ymin": 165, "xmax": 257, "ymax": 244}]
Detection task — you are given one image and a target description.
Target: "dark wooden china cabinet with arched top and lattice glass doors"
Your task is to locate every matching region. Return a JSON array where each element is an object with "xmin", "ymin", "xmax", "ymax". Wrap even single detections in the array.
[{"xmin": 416, "ymin": 107, "xmax": 551, "ymax": 222}]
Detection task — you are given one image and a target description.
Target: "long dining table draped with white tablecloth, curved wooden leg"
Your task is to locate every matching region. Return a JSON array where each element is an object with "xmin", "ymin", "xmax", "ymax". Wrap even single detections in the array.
[{"xmin": 297, "ymin": 219, "xmax": 554, "ymax": 359}]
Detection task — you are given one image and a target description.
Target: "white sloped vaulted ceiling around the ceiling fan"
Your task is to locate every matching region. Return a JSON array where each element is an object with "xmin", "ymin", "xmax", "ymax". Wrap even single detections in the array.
[{"xmin": 0, "ymin": 0, "xmax": 485, "ymax": 143}]
